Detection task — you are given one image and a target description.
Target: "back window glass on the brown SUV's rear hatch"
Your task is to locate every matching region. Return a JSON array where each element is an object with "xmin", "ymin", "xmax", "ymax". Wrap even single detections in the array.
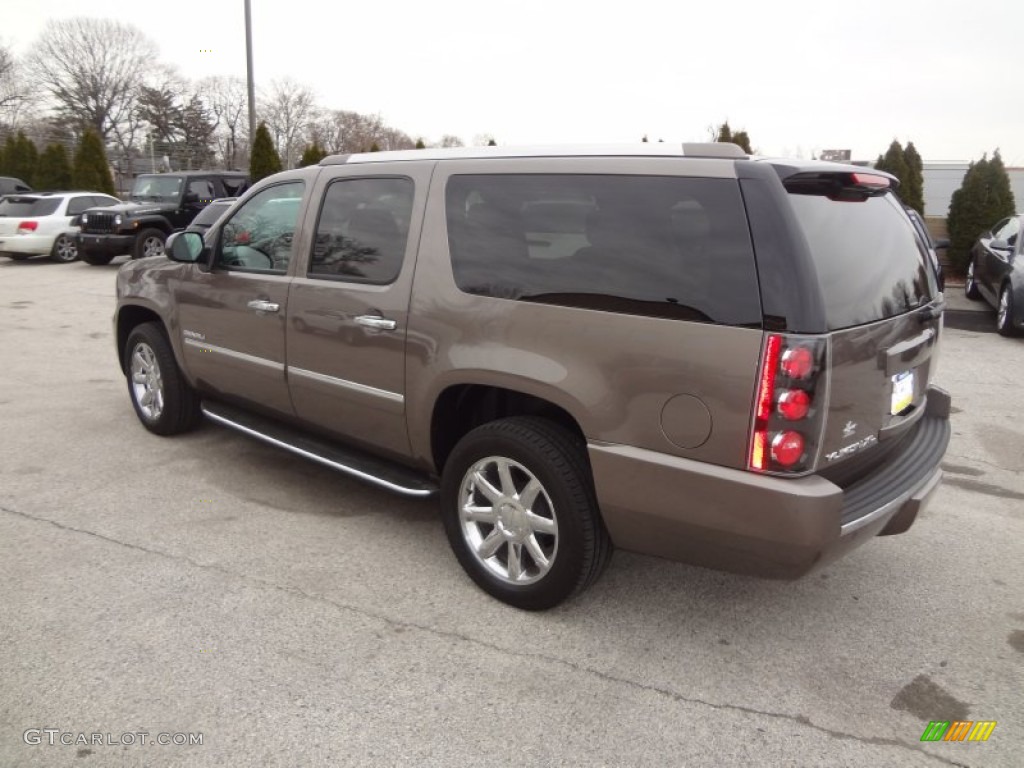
[{"xmin": 790, "ymin": 194, "xmax": 934, "ymax": 330}]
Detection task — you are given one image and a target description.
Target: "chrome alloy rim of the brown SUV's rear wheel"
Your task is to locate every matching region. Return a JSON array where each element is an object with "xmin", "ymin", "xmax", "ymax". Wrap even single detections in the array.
[{"xmin": 459, "ymin": 456, "xmax": 558, "ymax": 585}]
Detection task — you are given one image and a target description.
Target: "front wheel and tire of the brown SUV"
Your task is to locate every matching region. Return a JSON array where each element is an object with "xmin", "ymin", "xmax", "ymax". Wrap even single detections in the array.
[{"xmin": 124, "ymin": 323, "xmax": 200, "ymax": 435}]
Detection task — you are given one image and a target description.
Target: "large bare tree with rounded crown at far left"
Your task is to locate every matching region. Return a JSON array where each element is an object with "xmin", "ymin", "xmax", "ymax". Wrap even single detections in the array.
[{"xmin": 26, "ymin": 18, "xmax": 156, "ymax": 145}]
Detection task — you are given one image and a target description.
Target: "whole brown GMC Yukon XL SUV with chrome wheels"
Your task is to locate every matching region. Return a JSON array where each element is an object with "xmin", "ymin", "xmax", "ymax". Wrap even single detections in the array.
[{"xmin": 115, "ymin": 144, "xmax": 949, "ymax": 609}]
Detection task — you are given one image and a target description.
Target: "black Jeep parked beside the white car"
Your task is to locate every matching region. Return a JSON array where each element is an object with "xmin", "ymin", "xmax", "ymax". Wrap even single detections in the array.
[{"xmin": 78, "ymin": 171, "xmax": 249, "ymax": 264}]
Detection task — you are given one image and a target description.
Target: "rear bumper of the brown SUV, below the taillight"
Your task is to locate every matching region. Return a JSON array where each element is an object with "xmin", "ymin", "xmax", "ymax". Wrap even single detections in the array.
[{"xmin": 589, "ymin": 389, "xmax": 950, "ymax": 579}]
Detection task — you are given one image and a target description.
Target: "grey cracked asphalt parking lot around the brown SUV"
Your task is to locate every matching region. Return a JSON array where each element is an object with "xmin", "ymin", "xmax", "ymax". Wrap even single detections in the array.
[{"xmin": 0, "ymin": 260, "xmax": 1024, "ymax": 767}]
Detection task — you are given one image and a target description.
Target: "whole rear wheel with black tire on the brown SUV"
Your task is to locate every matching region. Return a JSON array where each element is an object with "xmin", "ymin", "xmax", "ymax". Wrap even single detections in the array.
[{"xmin": 441, "ymin": 417, "xmax": 611, "ymax": 610}]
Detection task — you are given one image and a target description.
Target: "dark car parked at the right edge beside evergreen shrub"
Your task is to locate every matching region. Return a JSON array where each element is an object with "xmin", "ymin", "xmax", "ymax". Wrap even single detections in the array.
[{"xmin": 964, "ymin": 214, "xmax": 1024, "ymax": 336}]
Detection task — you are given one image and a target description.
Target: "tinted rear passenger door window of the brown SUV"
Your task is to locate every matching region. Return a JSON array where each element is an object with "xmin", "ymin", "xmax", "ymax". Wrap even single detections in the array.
[{"xmin": 309, "ymin": 178, "xmax": 414, "ymax": 284}]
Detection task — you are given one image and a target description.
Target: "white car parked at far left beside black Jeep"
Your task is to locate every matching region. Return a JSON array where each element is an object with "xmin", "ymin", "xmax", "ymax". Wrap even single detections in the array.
[{"xmin": 0, "ymin": 191, "xmax": 120, "ymax": 262}]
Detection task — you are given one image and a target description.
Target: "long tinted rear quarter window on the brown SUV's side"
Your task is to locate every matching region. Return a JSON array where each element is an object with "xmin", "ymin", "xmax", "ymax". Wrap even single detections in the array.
[{"xmin": 446, "ymin": 174, "xmax": 761, "ymax": 327}]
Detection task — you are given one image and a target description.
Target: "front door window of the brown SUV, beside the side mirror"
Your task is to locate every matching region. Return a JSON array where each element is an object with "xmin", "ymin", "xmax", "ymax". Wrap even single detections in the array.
[{"xmin": 217, "ymin": 181, "xmax": 304, "ymax": 274}]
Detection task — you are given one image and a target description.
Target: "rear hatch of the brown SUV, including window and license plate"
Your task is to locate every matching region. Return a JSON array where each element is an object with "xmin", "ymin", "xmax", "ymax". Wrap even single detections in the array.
[{"xmin": 783, "ymin": 171, "xmax": 942, "ymax": 485}]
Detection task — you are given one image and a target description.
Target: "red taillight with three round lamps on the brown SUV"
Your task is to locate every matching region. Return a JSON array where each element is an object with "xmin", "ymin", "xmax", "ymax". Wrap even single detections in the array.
[{"xmin": 748, "ymin": 334, "xmax": 827, "ymax": 473}]
